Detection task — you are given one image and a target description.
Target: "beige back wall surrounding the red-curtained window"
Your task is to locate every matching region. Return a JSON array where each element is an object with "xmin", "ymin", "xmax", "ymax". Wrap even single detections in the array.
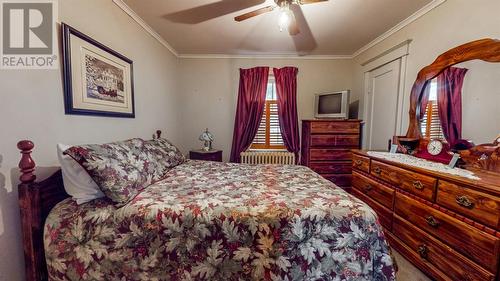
[{"xmin": 179, "ymin": 59, "xmax": 357, "ymax": 160}]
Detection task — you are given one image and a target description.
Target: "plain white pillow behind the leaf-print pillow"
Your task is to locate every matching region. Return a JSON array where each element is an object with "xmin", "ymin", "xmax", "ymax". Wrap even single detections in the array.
[{"xmin": 57, "ymin": 143, "xmax": 104, "ymax": 202}]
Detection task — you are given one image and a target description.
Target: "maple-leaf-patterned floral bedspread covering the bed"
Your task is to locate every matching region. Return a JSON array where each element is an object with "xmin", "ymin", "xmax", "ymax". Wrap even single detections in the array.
[{"xmin": 44, "ymin": 161, "xmax": 395, "ymax": 280}]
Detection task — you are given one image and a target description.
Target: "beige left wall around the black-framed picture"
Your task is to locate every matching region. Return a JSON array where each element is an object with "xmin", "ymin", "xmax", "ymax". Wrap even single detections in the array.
[{"xmin": 0, "ymin": 0, "xmax": 181, "ymax": 281}]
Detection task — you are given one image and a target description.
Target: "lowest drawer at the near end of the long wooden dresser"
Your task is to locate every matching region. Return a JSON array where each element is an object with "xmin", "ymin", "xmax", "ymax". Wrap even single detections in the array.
[{"xmin": 392, "ymin": 215, "xmax": 495, "ymax": 281}]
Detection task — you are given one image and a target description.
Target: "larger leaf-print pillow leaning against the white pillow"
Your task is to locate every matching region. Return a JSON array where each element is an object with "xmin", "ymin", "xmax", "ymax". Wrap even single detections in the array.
[{"xmin": 64, "ymin": 138, "xmax": 153, "ymax": 206}]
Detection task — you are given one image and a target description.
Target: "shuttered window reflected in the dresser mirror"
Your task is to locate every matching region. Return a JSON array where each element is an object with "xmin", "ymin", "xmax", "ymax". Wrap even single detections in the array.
[{"xmin": 420, "ymin": 79, "xmax": 444, "ymax": 139}]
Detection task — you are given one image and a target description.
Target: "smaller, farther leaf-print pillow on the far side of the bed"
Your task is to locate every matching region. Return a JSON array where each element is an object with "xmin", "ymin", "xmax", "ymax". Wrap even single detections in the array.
[{"xmin": 142, "ymin": 138, "xmax": 186, "ymax": 181}]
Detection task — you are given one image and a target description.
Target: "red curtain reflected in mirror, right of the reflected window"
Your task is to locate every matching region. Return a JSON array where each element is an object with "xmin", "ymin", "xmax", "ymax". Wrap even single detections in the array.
[{"xmin": 437, "ymin": 67, "xmax": 467, "ymax": 147}]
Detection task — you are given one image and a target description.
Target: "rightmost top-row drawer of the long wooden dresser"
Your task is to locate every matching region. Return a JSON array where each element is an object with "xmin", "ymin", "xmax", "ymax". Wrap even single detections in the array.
[{"xmin": 436, "ymin": 180, "xmax": 500, "ymax": 229}]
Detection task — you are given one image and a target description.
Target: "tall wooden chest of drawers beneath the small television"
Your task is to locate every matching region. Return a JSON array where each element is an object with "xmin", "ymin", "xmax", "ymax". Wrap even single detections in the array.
[{"xmin": 301, "ymin": 120, "xmax": 361, "ymax": 190}]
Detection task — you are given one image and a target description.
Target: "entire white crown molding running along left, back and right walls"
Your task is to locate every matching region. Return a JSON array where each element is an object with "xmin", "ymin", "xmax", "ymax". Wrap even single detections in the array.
[{"xmin": 113, "ymin": 0, "xmax": 446, "ymax": 60}]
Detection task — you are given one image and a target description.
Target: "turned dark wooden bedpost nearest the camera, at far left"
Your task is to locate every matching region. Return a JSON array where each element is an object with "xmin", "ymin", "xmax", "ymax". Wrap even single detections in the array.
[{"xmin": 17, "ymin": 140, "xmax": 47, "ymax": 281}]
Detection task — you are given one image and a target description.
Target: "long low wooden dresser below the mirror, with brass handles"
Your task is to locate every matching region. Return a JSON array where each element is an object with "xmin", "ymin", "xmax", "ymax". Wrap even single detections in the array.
[{"xmin": 352, "ymin": 150, "xmax": 500, "ymax": 281}]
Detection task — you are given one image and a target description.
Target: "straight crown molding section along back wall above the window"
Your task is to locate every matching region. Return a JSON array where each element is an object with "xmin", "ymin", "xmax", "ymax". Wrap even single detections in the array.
[{"xmin": 178, "ymin": 54, "xmax": 353, "ymax": 60}]
